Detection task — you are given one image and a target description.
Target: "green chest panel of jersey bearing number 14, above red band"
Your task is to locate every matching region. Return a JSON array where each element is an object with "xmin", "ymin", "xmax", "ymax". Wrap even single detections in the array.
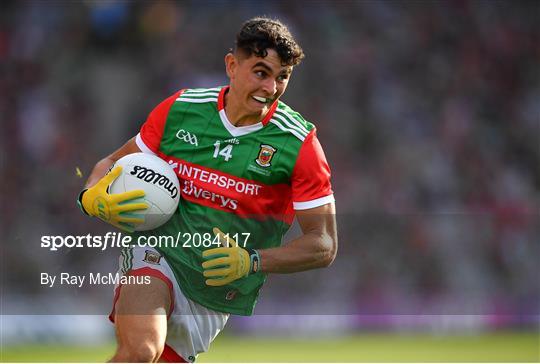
[{"xmin": 160, "ymin": 110, "xmax": 296, "ymax": 184}]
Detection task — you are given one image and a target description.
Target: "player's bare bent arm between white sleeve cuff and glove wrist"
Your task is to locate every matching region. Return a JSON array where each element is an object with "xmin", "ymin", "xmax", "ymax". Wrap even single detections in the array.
[{"xmin": 259, "ymin": 203, "xmax": 337, "ymax": 273}]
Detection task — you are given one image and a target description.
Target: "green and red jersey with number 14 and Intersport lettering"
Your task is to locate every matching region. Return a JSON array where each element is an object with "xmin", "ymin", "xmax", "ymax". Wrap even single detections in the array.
[{"xmin": 136, "ymin": 87, "xmax": 334, "ymax": 315}]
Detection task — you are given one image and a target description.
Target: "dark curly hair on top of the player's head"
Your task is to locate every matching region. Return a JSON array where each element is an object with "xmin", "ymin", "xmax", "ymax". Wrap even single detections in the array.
[{"xmin": 235, "ymin": 17, "xmax": 304, "ymax": 66}]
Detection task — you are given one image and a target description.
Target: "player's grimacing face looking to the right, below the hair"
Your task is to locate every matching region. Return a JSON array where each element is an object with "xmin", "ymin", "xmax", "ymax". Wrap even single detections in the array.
[{"xmin": 226, "ymin": 49, "xmax": 292, "ymax": 116}]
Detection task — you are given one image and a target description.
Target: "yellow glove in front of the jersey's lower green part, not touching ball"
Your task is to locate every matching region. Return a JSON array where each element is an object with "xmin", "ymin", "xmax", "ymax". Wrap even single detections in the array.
[{"xmin": 202, "ymin": 228, "xmax": 260, "ymax": 286}]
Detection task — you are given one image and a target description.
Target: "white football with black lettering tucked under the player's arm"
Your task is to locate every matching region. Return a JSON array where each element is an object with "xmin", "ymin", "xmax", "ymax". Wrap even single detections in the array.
[{"xmin": 109, "ymin": 153, "xmax": 180, "ymax": 231}]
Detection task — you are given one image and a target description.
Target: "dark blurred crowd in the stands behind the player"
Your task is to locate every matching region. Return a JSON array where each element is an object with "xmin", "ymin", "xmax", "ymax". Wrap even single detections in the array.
[{"xmin": 0, "ymin": 0, "xmax": 540, "ymax": 342}]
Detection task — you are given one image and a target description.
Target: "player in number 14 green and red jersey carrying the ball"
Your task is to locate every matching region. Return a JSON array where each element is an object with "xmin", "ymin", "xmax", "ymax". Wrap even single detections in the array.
[{"xmin": 79, "ymin": 18, "xmax": 337, "ymax": 362}]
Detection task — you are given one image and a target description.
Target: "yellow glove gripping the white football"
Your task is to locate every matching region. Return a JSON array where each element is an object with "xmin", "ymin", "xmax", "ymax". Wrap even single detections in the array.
[{"xmin": 78, "ymin": 166, "xmax": 148, "ymax": 232}]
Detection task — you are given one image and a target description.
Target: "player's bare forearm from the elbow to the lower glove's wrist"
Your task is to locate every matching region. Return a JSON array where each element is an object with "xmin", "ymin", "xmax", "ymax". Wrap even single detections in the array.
[{"xmin": 259, "ymin": 232, "xmax": 337, "ymax": 273}]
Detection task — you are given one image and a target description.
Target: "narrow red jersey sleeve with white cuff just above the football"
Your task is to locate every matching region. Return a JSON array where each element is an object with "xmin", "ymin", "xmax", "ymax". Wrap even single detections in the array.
[{"xmin": 135, "ymin": 90, "xmax": 184, "ymax": 154}]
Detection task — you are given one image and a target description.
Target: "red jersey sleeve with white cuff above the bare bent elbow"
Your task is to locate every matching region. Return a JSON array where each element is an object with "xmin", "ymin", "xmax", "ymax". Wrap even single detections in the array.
[{"xmin": 292, "ymin": 129, "xmax": 334, "ymax": 210}]
